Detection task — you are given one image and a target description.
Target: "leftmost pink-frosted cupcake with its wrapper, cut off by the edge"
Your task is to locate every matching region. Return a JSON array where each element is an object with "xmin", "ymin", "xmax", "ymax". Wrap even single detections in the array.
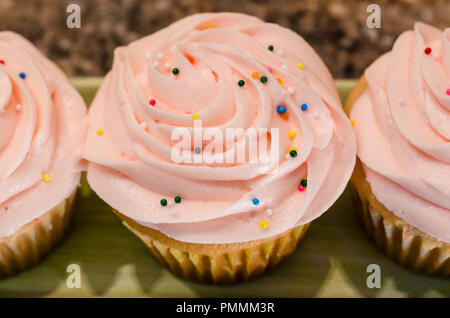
[{"xmin": 0, "ymin": 32, "xmax": 87, "ymax": 277}]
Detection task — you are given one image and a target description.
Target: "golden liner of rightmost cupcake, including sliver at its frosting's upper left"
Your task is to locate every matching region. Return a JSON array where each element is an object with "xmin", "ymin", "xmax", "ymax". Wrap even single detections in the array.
[{"xmin": 345, "ymin": 77, "xmax": 450, "ymax": 278}]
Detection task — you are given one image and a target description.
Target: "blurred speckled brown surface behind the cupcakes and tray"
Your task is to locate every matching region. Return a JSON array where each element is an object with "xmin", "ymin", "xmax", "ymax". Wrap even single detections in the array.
[{"xmin": 0, "ymin": 0, "xmax": 450, "ymax": 78}]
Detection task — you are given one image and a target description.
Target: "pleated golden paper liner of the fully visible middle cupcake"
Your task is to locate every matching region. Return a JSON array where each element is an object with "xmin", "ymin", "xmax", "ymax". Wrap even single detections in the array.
[{"xmin": 114, "ymin": 211, "xmax": 310, "ymax": 285}]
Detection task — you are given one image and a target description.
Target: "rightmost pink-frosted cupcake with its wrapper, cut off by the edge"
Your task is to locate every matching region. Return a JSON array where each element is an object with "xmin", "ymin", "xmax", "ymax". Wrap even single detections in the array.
[{"xmin": 345, "ymin": 23, "xmax": 450, "ymax": 277}]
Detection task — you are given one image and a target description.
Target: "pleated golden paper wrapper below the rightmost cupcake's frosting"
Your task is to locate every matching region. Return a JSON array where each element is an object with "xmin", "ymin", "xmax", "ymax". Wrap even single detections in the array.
[{"xmin": 353, "ymin": 167, "xmax": 450, "ymax": 278}]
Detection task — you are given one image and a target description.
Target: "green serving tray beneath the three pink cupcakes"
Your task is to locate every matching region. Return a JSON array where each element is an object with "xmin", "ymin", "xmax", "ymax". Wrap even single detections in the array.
[{"xmin": 0, "ymin": 78, "xmax": 450, "ymax": 297}]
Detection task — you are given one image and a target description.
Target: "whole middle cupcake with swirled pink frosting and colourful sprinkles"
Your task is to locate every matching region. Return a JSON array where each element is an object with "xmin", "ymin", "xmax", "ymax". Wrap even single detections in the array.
[{"xmin": 83, "ymin": 13, "xmax": 356, "ymax": 284}]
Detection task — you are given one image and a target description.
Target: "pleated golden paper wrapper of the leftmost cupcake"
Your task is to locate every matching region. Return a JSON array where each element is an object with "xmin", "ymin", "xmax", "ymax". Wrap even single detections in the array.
[{"xmin": 0, "ymin": 190, "xmax": 76, "ymax": 278}]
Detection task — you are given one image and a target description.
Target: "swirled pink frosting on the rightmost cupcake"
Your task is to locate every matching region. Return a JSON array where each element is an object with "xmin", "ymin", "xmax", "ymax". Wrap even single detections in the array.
[{"xmin": 351, "ymin": 23, "xmax": 450, "ymax": 242}]
